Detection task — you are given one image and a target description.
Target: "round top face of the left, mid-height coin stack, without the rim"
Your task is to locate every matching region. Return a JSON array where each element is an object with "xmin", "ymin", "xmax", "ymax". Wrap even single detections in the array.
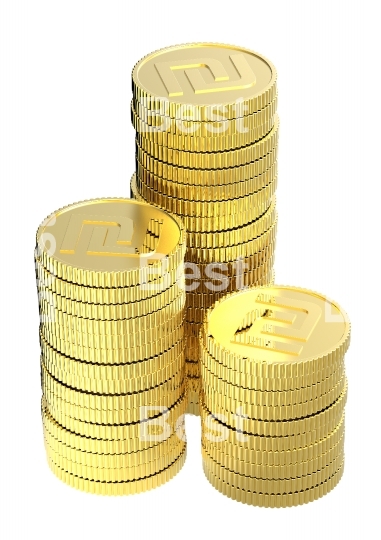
[{"xmin": 37, "ymin": 199, "xmax": 181, "ymax": 272}]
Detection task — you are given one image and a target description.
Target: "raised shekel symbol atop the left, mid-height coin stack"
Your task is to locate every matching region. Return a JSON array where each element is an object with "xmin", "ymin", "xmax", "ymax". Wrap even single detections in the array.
[{"xmin": 60, "ymin": 214, "xmax": 162, "ymax": 260}]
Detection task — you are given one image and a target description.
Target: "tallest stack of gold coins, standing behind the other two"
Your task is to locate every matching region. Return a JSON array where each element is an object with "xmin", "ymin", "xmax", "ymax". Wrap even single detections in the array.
[{"xmin": 131, "ymin": 43, "xmax": 278, "ymax": 414}]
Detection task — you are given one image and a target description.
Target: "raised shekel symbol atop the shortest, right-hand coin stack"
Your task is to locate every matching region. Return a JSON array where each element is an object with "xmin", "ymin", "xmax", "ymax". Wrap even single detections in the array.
[{"xmin": 232, "ymin": 295, "xmax": 323, "ymax": 356}]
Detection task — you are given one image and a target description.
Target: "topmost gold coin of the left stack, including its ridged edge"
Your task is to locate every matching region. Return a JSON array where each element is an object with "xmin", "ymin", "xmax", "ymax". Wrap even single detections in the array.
[{"xmin": 36, "ymin": 199, "xmax": 185, "ymax": 287}]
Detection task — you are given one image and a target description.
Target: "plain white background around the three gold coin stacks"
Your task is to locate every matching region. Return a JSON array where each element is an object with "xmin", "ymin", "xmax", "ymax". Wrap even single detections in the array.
[{"xmin": 0, "ymin": 0, "xmax": 380, "ymax": 539}]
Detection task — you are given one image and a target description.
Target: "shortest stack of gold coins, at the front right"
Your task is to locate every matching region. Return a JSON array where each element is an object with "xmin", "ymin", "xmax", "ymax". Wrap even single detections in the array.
[{"xmin": 201, "ymin": 286, "xmax": 350, "ymax": 507}]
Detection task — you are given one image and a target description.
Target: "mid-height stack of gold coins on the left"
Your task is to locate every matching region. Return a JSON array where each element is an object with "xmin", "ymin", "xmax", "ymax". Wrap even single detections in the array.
[{"xmin": 35, "ymin": 199, "xmax": 187, "ymax": 495}]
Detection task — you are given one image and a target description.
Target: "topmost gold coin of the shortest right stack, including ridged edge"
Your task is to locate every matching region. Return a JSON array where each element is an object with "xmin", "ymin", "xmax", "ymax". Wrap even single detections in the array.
[{"xmin": 203, "ymin": 286, "xmax": 350, "ymax": 380}]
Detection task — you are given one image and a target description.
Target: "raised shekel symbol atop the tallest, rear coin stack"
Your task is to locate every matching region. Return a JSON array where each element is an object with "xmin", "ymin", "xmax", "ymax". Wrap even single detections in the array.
[{"xmin": 155, "ymin": 54, "xmax": 256, "ymax": 97}]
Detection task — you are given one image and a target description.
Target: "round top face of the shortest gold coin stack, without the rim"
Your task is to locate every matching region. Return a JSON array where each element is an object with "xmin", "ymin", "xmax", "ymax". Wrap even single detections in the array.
[{"xmin": 207, "ymin": 286, "xmax": 350, "ymax": 363}]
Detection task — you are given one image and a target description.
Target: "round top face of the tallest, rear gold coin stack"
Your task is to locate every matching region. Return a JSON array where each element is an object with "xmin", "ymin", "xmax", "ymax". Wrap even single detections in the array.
[{"xmin": 132, "ymin": 43, "xmax": 276, "ymax": 116}]
